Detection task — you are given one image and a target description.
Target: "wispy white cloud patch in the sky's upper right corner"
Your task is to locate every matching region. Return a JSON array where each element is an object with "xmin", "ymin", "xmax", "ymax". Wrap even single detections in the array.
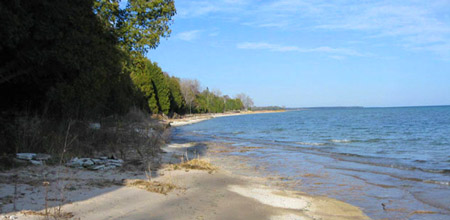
[{"xmin": 316, "ymin": 5, "xmax": 450, "ymax": 39}]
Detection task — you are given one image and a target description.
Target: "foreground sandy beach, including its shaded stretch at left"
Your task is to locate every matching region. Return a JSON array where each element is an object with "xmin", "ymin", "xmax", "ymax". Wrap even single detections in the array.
[{"xmin": 0, "ymin": 115, "xmax": 369, "ymax": 219}]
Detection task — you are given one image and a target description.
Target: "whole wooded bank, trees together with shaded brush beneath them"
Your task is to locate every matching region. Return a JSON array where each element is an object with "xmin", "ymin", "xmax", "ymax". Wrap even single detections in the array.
[{"xmin": 0, "ymin": 0, "xmax": 253, "ymax": 156}]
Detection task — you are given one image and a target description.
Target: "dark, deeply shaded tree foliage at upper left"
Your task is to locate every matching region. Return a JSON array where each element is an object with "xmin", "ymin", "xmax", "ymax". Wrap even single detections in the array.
[{"xmin": 0, "ymin": 0, "xmax": 133, "ymax": 118}]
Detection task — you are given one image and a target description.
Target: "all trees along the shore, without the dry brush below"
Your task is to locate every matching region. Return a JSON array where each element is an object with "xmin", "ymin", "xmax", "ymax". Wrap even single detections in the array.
[{"xmin": 0, "ymin": 0, "xmax": 251, "ymax": 121}]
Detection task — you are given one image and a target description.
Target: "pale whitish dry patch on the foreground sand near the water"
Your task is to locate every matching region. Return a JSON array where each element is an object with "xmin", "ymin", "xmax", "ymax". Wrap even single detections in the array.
[{"xmin": 228, "ymin": 185, "xmax": 310, "ymax": 210}]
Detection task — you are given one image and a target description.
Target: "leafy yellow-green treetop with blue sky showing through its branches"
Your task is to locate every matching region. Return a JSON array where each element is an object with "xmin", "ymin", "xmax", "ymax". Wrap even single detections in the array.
[{"xmin": 94, "ymin": 0, "xmax": 176, "ymax": 54}]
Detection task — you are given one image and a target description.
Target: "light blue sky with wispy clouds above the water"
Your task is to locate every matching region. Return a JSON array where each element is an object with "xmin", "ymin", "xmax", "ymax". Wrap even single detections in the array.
[{"xmin": 147, "ymin": 0, "xmax": 450, "ymax": 107}]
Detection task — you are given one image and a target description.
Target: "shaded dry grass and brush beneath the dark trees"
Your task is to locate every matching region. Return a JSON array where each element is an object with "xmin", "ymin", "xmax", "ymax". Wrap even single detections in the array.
[{"xmin": 0, "ymin": 109, "xmax": 170, "ymax": 169}]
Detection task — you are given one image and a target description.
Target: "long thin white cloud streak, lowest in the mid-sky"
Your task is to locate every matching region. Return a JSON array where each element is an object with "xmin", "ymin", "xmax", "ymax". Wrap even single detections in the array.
[{"xmin": 236, "ymin": 42, "xmax": 371, "ymax": 57}]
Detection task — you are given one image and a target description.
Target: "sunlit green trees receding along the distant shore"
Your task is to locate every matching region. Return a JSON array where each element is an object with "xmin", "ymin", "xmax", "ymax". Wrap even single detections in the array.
[{"xmin": 130, "ymin": 57, "xmax": 245, "ymax": 117}]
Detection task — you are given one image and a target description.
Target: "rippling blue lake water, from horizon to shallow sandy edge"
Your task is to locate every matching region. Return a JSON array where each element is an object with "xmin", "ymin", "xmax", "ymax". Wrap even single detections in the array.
[{"xmin": 174, "ymin": 106, "xmax": 450, "ymax": 219}]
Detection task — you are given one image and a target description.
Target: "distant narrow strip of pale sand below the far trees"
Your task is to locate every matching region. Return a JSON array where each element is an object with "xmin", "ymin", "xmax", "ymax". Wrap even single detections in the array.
[{"xmin": 164, "ymin": 110, "xmax": 287, "ymax": 127}]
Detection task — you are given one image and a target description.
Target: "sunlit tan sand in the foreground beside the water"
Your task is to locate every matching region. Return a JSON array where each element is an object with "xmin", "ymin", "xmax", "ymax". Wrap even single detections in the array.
[{"xmin": 1, "ymin": 170, "xmax": 368, "ymax": 219}]
